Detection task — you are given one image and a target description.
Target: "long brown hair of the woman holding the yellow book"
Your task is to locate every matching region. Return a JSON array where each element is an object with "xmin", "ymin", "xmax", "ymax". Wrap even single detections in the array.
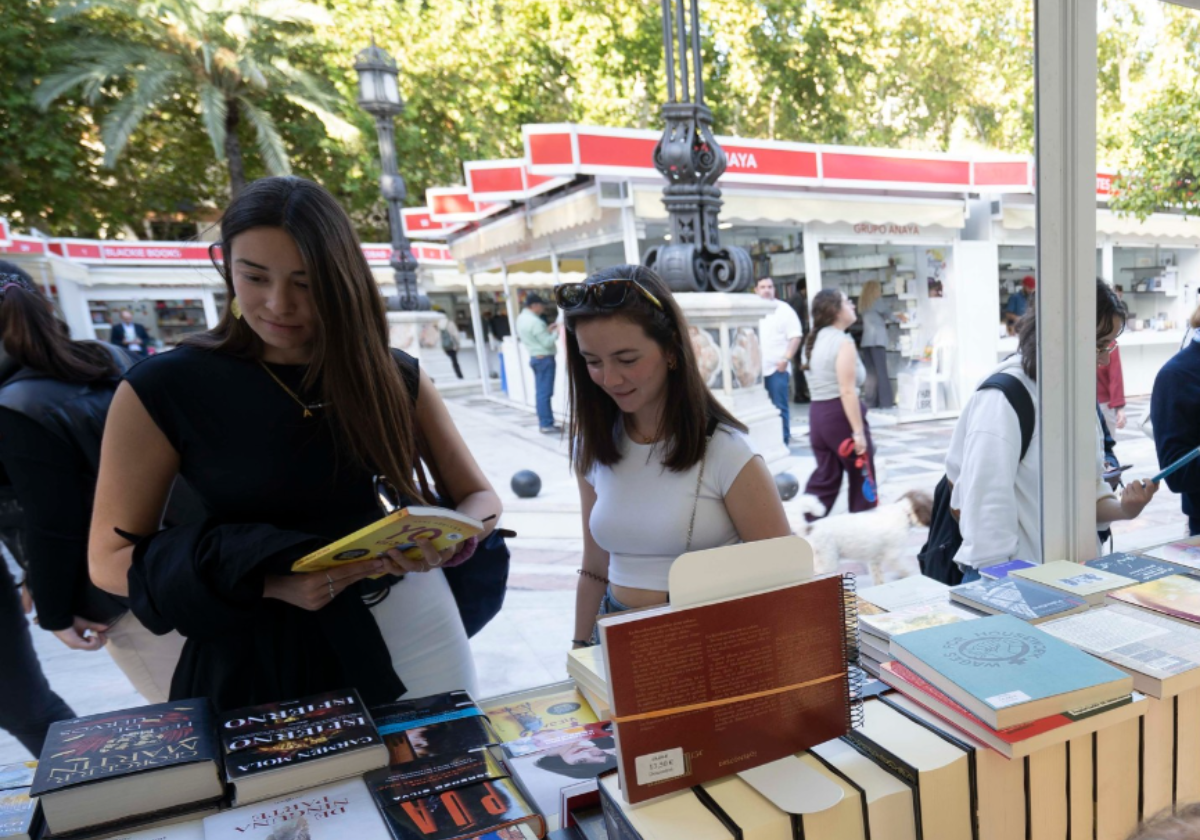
[{"xmin": 185, "ymin": 176, "xmax": 424, "ymax": 499}]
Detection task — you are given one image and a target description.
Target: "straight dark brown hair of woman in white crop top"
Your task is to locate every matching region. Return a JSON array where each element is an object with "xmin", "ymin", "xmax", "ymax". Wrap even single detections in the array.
[{"xmin": 565, "ymin": 265, "xmax": 746, "ymax": 475}]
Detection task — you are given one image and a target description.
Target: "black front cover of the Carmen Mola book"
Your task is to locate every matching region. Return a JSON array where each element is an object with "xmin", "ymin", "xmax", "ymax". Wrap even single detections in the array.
[{"xmin": 220, "ymin": 689, "xmax": 383, "ymax": 782}]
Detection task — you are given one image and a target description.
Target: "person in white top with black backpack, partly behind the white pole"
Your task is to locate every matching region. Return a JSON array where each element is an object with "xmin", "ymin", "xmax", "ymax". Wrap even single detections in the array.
[{"xmin": 940, "ymin": 280, "xmax": 1158, "ymax": 582}]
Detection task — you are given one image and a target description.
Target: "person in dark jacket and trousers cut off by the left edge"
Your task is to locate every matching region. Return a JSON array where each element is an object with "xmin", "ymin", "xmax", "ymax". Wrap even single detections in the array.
[{"xmin": 0, "ymin": 262, "xmax": 106, "ymax": 756}]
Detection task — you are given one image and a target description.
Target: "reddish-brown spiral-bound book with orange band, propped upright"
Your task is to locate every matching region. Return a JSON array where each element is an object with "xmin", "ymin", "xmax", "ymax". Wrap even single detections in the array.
[{"xmin": 600, "ymin": 575, "xmax": 862, "ymax": 804}]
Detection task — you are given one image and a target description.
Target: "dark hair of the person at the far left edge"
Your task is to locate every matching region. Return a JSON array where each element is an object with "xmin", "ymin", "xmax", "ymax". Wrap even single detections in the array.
[{"xmin": 0, "ymin": 260, "xmax": 121, "ymax": 384}]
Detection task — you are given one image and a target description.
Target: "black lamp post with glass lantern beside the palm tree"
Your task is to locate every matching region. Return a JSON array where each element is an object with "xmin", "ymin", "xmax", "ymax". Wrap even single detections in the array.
[{"xmin": 354, "ymin": 38, "xmax": 430, "ymax": 311}]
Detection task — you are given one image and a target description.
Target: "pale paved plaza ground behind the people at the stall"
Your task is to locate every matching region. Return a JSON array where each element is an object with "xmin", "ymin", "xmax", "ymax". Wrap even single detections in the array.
[{"xmin": 0, "ymin": 396, "xmax": 1186, "ymax": 764}]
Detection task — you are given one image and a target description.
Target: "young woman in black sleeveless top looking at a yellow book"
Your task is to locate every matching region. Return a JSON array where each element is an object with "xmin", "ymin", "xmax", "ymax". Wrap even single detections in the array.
[{"xmin": 90, "ymin": 178, "xmax": 500, "ymax": 708}]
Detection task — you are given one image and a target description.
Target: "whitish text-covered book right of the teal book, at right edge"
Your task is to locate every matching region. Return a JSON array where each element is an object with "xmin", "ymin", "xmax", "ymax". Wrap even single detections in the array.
[{"xmin": 1042, "ymin": 604, "xmax": 1200, "ymax": 698}]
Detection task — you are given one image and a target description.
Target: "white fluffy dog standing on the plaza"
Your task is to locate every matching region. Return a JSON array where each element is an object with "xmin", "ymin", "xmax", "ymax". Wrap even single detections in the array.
[{"xmin": 799, "ymin": 490, "xmax": 934, "ymax": 583}]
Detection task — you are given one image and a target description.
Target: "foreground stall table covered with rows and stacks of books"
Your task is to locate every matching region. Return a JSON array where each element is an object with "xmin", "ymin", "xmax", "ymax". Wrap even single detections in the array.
[{"xmin": 11, "ymin": 538, "xmax": 1200, "ymax": 840}]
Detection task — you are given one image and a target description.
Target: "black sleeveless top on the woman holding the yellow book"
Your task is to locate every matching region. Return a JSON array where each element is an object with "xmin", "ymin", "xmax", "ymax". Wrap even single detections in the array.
[{"xmin": 126, "ymin": 346, "xmax": 420, "ymax": 540}]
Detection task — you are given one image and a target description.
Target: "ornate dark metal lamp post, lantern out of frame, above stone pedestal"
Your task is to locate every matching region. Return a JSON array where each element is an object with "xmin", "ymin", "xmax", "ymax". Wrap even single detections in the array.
[{"xmin": 646, "ymin": 0, "xmax": 754, "ymax": 292}]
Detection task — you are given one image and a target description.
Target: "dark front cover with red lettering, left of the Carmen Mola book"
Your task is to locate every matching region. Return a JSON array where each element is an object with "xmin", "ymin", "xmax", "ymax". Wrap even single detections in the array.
[{"xmin": 31, "ymin": 698, "xmax": 218, "ymax": 797}]
